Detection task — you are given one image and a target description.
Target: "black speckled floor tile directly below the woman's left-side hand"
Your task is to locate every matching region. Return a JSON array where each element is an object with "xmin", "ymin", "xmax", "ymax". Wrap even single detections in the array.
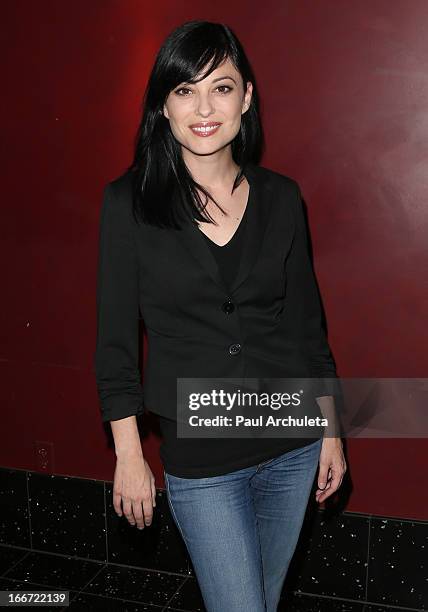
[{"xmin": 83, "ymin": 565, "xmax": 185, "ymax": 606}]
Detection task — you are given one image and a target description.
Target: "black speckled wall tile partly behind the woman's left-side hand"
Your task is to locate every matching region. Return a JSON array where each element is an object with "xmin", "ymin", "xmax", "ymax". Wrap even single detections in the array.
[{"xmin": 106, "ymin": 483, "xmax": 189, "ymax": 577}]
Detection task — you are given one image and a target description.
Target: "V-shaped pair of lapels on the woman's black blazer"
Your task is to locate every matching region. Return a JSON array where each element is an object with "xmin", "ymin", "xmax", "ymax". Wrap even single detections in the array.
[{"xmin": 177, "ymin": 164, "xmax": 272, "ymax": 294}]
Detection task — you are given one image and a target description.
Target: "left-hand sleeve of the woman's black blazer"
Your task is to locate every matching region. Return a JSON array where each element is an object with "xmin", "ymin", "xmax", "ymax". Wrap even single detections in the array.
[{"xmin": 94, "ymin": 183, "xmax": 143, "ymax": 421}]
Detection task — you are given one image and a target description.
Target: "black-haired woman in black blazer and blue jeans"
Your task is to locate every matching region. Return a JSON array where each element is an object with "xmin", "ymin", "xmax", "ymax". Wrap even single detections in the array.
[{"xmin": 95, "ymin": 21, "xmax": 346, "ymax": 612}]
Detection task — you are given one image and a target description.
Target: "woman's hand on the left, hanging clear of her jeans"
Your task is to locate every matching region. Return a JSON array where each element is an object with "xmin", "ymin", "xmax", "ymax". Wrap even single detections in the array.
[{"xmin": 113, "ymin": 453, "xmax": 156, "ymax": 529}]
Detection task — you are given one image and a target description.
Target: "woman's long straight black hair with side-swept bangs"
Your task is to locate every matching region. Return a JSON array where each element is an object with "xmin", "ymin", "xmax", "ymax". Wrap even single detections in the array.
[{"xmin": 127, "ymin": 21, "xmax": 263, "ymax": 229}]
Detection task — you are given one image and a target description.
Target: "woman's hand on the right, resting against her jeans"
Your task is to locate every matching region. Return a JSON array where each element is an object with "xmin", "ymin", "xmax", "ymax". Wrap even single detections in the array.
[{"xmin": 315, "ymin": 438, "xmax": 346, "ymax": 503}]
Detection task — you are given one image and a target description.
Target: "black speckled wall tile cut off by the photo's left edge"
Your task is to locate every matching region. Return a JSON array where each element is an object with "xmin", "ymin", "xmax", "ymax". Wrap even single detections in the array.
[{"xmin": 0, "ymin": 468, "xmax": 30, "ymax": 548}]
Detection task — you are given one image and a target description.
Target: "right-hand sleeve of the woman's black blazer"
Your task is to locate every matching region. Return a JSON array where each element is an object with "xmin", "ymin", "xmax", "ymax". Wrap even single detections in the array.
[{"xmin": 286, "ymin": 182, "xmax": 339, "ymax": 397}]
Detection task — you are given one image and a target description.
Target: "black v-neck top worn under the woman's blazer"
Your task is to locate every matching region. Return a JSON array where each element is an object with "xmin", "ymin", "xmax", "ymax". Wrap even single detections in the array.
[{"xmin": 155, "ymin": 191, "xmax": 315, "ymax": 478}]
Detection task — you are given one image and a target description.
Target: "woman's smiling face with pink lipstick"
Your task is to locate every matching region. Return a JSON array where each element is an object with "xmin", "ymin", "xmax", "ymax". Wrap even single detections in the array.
[{"xmin": 163, "ymin": 59, "xmax": 253, "ymax": 155}]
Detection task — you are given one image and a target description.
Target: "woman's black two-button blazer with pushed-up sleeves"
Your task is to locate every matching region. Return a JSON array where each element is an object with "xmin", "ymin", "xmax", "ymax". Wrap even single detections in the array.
[{"xmin": 94, "ymin": 164, "xmax": 336, "ymax": 421}]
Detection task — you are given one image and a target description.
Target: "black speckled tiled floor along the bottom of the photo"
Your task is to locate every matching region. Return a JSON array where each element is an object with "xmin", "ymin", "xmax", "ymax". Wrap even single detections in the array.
[{"xmin": 0, "ymin": 545, "xmax": 422, "ymax": 612}]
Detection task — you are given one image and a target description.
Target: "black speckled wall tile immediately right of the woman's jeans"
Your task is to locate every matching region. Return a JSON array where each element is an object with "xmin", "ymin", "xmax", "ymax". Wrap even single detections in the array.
[{"xmin": 283, "ymin": 510, "xmax": 369, "ymax": 601}]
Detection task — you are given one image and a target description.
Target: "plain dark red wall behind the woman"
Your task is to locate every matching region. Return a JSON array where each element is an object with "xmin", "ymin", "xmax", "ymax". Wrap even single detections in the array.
[{"xmin": 0, "ymin": 0, "xmax": 428, "ymax": 519}]
